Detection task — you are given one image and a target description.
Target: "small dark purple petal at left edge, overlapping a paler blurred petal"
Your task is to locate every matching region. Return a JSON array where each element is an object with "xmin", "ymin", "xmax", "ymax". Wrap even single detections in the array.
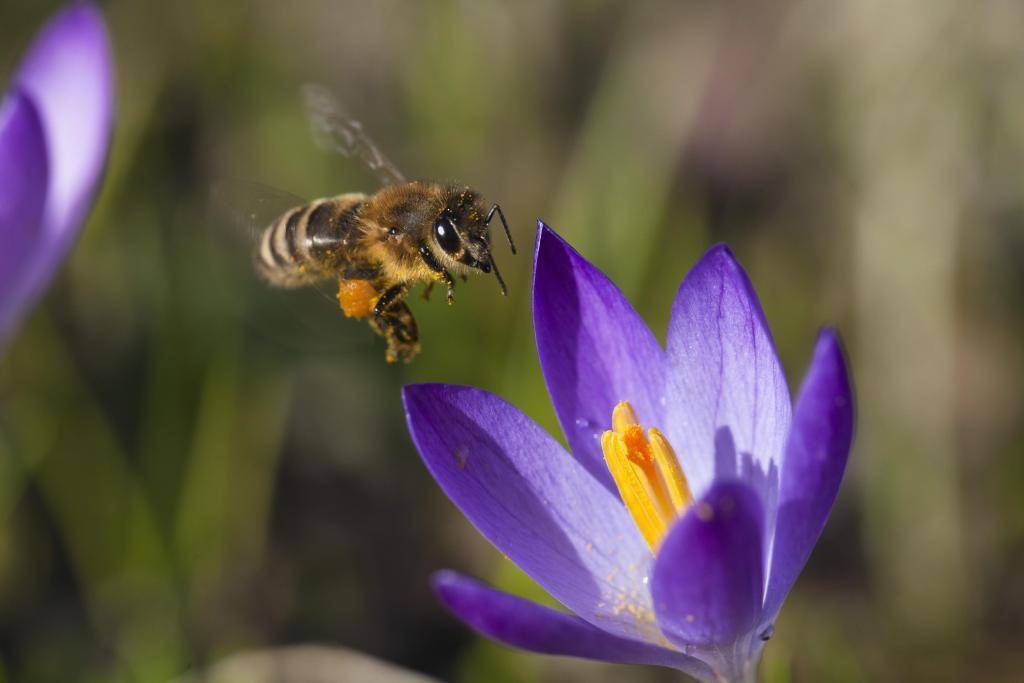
[{"xmin": 0, "ymin": 89, "xmax": 47, "ymax": 346}]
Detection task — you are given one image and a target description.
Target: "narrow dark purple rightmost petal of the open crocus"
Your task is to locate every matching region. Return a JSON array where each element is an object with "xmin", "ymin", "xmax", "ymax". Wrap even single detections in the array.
[{"xmin": 765, "ymin": 330, "xmax": 854, "ymax": 620}]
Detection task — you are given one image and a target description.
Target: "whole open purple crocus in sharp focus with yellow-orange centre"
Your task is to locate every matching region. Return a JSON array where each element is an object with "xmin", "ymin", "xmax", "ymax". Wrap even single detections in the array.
[{"xmin": 403, "ymin": 223, "xmax": 853, "ymax": 681}]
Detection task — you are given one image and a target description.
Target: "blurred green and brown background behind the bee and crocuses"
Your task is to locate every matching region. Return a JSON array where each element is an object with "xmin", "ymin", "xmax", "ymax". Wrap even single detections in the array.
[{"xmin": 0, "ymin": 0, "xmax": 1024, "ymax": 682}]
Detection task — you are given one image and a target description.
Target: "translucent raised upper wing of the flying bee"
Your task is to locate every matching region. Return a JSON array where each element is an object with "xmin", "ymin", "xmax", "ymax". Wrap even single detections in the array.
[{"xmin": 302, "ymin": 84, "xmax": 407, "ymax": 185}]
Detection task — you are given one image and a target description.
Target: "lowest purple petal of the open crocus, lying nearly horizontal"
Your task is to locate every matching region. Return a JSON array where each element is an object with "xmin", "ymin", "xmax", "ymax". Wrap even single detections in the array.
[{"xmin": 432, "ymin": 571, "xmax": 711, "ymax": 680}]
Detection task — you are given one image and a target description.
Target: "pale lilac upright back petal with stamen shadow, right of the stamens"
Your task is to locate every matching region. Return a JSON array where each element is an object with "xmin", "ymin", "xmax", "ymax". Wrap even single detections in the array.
[{"xmin": 666, "ymin": 245, "xmax": 792, "ymax": 538}]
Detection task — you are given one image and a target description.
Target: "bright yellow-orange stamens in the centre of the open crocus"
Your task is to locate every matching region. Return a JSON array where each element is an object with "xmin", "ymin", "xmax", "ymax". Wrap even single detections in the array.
[{"xmin": 601, "ymin": 400, "xmax": 692, "ymax": 552}]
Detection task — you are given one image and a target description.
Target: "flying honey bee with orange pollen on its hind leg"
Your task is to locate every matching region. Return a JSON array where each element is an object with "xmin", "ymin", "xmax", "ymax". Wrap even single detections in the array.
[{"xmin": 253, "ymin": 86, "xmax": 515, "ymax": 362}]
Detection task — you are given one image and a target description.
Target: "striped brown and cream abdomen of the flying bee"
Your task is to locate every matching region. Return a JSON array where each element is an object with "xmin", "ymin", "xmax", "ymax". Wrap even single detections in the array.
[{"xmin": 254, "ymin": 193, "xmax": 366, "ymax": 287}]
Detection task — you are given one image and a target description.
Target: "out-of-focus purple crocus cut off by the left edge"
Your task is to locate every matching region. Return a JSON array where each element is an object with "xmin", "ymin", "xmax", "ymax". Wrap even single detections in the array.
[{"xmin": 0, "ymin": 2, "xmax": 114, "ymax": 348}]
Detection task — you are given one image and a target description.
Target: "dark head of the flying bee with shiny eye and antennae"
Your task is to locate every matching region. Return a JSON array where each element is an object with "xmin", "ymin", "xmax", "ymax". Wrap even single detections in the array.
[{"xmin": 431, "ymin": 189, "xmax": 515, "ymax": 294}]
